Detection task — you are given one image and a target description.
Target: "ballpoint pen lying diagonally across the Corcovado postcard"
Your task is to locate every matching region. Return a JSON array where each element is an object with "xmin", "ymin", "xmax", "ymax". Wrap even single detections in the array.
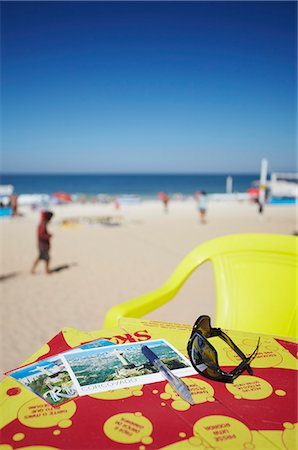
[{"xmin": 141, "ymin": 345, "xmax": 195, "ymax": 405}]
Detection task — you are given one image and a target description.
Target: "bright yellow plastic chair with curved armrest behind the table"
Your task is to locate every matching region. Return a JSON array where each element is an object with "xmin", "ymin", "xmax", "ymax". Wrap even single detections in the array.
[{"xmin": 104, "ymin": 234, "xmax": 297, "ymax": 336}]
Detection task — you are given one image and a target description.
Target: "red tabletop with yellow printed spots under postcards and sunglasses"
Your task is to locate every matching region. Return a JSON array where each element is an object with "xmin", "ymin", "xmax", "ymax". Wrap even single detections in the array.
[{"xmin": 0, "ymin": 319, "xmax": 297, "ymax": 450}]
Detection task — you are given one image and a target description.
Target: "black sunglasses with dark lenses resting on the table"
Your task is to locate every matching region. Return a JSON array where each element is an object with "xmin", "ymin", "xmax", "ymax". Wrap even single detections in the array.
[{"xmin": 187, "ymin": 316, "xmax": 260, "ymax": 383}]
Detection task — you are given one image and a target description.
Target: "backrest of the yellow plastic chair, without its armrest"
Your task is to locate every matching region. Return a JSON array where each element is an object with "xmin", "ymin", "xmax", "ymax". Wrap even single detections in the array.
[{"xmin": 206, "ymin": 234, "xmax": 297, "ymax": 336}]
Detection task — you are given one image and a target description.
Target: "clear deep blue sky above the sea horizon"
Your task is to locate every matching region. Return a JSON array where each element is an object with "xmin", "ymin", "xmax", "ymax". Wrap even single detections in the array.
[{"xmin": 1, "ymin": 1, "xmax": 297, "ymax": 173}]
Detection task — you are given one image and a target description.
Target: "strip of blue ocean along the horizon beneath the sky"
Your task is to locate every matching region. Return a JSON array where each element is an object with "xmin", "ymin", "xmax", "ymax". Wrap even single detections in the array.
[{"xmin": 0, "ymin": 174, "xmax": 259, "ymax": 198}]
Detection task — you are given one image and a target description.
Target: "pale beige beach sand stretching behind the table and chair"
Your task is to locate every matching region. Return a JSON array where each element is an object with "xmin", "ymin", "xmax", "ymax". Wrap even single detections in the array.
[{"xmin": 0, "ymin": 200, "xmax": 296, "ymax": 372}]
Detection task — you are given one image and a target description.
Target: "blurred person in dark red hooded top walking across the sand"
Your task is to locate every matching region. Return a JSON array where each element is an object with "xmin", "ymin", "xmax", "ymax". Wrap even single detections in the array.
[{"xmin": 31, "ymin": 211, "xmax": 53, "ymax": 274}]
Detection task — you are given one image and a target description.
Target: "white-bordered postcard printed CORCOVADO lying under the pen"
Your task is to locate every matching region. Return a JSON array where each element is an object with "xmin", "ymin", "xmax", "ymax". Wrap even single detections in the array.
[{"xmin": 61, "ymin": 339, "xmax": 196, "ymax": 395}]
